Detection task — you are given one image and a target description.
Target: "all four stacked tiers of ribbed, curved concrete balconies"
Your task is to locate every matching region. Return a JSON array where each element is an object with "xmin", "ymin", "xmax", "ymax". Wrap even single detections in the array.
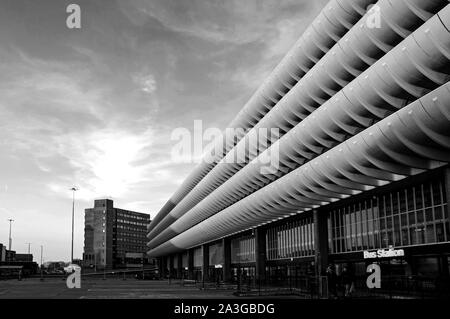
[{"xmin": 148, "ymin": 0, "xmax": 450, "ymax": 298}]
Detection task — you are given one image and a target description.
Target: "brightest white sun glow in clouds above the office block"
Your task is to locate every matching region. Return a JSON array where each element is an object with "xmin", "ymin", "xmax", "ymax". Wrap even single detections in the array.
[{"xmin": 57, "ymin": 130, "xmax": 156, "ymax": 199}]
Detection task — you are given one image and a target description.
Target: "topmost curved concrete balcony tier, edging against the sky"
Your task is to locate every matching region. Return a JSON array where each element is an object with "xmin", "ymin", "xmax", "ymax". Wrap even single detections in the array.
[{"xmin": 148, "ymin": 0, "xmax": 376, "ymax": 235}]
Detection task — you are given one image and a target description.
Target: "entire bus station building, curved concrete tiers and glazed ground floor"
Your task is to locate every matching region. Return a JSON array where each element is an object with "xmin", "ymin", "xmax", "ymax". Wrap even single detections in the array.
[{"xmin": 148, "ymin": 0, "xmax": 450, "ymax": 298}]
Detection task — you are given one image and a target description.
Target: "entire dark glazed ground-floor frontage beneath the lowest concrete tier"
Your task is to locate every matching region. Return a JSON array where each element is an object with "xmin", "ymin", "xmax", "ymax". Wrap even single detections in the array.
[{"xmin": 159, "ymin": 170, "xmax": 450, "ymax": 298}]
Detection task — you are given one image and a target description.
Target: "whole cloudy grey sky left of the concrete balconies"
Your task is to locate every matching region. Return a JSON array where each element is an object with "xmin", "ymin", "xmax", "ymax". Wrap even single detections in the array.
[{"xmin": 0, "ymin": 0, "xmax": 328, "ymax": 261}]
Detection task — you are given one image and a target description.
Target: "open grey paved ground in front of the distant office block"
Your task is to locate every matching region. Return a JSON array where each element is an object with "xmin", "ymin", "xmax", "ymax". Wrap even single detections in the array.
[{"xmin": 0, "ymin": 278, "xmax": 253, "ymax": 299}]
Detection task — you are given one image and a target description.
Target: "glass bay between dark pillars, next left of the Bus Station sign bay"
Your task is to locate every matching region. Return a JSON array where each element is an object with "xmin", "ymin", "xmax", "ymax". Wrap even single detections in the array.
[{"xmin": 266, "ymin": 217, "xmax": 314, "ymax": 260}]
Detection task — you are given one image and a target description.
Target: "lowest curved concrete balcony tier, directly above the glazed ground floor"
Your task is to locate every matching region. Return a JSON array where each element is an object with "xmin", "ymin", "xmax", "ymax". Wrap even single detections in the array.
[{"xmin": 148, "ymin": 83, "xmax": 450, "ymax": 256}]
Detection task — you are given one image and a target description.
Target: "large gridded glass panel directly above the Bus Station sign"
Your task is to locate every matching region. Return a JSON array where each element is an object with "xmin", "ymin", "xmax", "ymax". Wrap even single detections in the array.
[{"xmin": 328, "ymin": 179, "xmax": 450, "ymax": 253}]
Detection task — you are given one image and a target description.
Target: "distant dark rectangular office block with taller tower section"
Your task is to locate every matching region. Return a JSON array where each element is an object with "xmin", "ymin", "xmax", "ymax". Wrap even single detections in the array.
[{"xmin": 83, "ymin": 199, "xmax": 150, "ymax": 268}]
